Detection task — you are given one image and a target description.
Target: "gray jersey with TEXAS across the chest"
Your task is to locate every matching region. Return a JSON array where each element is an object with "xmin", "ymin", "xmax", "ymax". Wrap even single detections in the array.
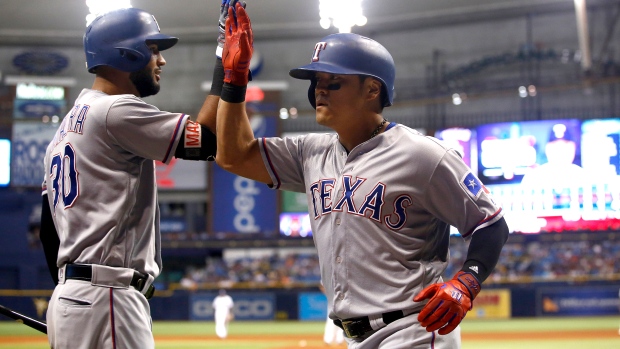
[{"xmin": 259, "ymin": 123, "xmax": 503, "ymax": 319}]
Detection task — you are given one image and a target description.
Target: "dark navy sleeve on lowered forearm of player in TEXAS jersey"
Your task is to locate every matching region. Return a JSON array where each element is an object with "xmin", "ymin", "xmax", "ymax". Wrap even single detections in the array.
[{"xmin": 461, "ymin": 218, "xmax": 509, "ymax": 282}]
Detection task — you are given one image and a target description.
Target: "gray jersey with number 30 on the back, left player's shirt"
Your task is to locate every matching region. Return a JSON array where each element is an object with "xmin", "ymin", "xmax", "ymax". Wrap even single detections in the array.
[{"xmin": 43, "ymin": 89, "xmax": 189, "ymax": 277}]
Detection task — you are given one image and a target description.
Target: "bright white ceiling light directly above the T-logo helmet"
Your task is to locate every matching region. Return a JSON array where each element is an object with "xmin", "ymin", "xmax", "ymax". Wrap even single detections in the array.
[{"xmin": 319, "ymin": 0, "xmax": 368, "ymax": 33}]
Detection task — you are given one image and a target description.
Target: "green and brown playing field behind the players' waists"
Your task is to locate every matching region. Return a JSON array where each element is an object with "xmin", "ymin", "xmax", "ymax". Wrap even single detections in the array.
[{"xmin": 0, "ymin": 316, "xmax": 620, "ymax": 349}]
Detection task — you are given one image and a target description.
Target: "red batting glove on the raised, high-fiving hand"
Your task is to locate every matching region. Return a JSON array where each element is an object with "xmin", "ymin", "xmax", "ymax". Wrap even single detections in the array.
[{"xmin": 222, "ymin": 2, "xmax": 254, "ymax": 86}]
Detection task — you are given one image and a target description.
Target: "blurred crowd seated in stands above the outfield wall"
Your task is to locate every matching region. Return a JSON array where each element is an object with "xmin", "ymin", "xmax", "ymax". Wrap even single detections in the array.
[{"xmin": 170, "ymin": 237, "xmax": 620, "ymax": 289}]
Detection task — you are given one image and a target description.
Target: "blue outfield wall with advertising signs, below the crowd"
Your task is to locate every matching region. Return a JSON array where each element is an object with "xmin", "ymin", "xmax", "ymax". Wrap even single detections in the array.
[{"xmin": 0, "ymin": 281, "xmax": 620, "ymax": 321}]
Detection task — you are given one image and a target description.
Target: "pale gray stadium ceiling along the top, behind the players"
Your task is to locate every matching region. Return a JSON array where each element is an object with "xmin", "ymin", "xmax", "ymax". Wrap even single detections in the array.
[{"xmin": 0, "ymin": 0, "xmax": 618, "ymax": 46}]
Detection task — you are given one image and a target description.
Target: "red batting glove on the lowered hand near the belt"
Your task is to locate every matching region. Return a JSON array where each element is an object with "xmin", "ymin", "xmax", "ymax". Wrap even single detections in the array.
[{"xmin": 413, "ymin": 271, "xmax": 480, "ymax": 335}]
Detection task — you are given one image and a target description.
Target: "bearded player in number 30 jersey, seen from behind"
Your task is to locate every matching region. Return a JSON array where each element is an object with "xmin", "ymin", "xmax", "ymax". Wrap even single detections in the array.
[{"xmin": 41, "ymin": 4, "xmax": 236, "ymax": 349}]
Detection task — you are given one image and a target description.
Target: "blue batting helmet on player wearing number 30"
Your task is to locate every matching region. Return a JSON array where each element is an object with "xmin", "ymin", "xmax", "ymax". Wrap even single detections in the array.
[{"xmin": 84, "ymin": 8, "xmax": 179, "ymax": 73}]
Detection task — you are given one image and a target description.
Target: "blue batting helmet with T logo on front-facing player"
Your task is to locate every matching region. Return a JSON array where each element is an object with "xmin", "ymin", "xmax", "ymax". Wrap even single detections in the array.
[{"xmin": 289, "ymin": 33, "xmax": 396, "ymax": 108}]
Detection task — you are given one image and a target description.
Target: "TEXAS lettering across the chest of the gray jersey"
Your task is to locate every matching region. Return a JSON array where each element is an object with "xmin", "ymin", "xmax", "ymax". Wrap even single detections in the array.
[{"xmin": 310, "ymin": 175, "xmax": 413, "ymax": 230}]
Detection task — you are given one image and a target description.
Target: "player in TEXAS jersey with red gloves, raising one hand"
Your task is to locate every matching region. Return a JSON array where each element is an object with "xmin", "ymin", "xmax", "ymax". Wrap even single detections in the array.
[{"xmin": 216, "ymin": 6, "xmax": 508, "ymax": 349}]
